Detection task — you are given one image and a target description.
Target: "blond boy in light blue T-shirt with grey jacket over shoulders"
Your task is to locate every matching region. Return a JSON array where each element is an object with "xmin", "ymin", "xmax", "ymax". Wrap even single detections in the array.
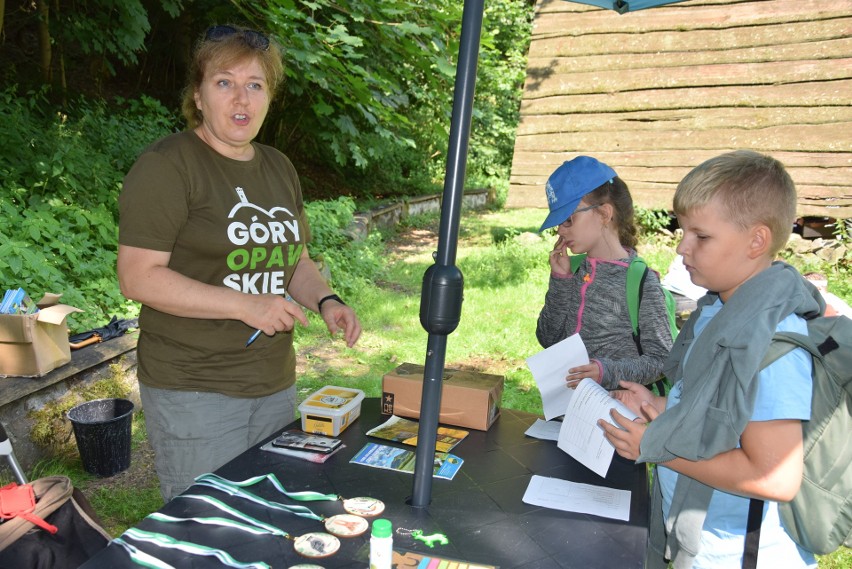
[{"xmin": 601, "ymin": 151, "xmax": 825, "ymax": 569}]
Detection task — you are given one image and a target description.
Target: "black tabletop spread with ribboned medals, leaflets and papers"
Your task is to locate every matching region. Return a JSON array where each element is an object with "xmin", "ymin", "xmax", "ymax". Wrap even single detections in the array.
[{"xmin": 82, "ymin": 399, "xmax": 648, "ymax": 569}]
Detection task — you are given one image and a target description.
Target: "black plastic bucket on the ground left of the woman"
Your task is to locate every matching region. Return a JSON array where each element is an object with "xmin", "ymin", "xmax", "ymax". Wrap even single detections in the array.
[{"xmin": 68, "ymin": 399, "xmax": 133, "ymax": 477}]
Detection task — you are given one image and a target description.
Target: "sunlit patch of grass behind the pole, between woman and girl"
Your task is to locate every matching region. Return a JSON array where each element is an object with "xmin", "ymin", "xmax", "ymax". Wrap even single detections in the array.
[{"xmin": 296, "ymin": 206, "xmax": 549, "ymax": 413}]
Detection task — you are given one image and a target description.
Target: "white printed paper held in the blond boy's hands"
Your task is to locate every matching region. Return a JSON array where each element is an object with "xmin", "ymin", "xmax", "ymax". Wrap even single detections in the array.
[{"xmin": 557, "ymin": 378, "xmax": 637, "ymax": 477}]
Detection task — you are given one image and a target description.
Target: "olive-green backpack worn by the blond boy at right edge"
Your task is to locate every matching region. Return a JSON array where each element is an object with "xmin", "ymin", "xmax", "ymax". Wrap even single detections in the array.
[{"xmin": 762, "ymin": 316, "xmax": 852, "ymax": 555}]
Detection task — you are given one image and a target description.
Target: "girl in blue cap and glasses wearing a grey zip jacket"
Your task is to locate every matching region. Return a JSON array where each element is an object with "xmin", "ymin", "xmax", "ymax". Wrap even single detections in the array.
[{"xmin": 536, "ymin": 156, "xmax": 672, "ymax": 389}]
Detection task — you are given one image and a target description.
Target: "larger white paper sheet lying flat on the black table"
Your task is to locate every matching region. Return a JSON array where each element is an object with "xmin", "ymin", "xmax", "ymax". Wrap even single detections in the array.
[{"xmin": 523, "ymin": 475, "xmax": 630, "ymax": 522}]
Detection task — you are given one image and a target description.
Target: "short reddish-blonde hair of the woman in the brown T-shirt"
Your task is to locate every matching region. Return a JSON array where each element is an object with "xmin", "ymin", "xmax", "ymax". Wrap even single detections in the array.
[{"xmin": 181, "ymin": 26, "xmax": 284, "ymax": 129}]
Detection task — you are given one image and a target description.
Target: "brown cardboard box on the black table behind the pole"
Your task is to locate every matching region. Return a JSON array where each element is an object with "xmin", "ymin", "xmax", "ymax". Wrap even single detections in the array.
[{"xmin": 382, "ymin": 363, "xmax": 504, "ymax": 431}]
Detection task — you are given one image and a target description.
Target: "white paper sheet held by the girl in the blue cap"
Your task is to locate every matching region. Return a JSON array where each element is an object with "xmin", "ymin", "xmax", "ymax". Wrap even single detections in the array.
[{"xmin": 527, "ymin": 334, "xmax": 589, "ymax": 421}]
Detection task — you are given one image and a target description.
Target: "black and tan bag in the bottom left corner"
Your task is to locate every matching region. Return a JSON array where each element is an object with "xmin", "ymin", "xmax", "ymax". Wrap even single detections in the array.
[{"xmin": 0, "ymin": 476, "xmax": 112, "ymax": 569}]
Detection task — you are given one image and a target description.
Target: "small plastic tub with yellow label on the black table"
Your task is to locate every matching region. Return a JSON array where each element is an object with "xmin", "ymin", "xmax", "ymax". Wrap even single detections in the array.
[{"xmin": 299, "ymin": 385, "xmax": 364, "ymax": 437}]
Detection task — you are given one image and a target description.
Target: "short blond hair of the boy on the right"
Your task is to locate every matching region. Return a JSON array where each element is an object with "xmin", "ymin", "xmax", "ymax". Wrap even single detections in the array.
[{"xmin": 674, "ymin": 150, "xmax": 796, "ymax": 255}]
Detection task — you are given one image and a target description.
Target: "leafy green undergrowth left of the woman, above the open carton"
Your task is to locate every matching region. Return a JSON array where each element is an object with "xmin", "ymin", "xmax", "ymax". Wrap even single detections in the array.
[{"xmin": 0, "ymin": 88, "xmax": 173, "ymax": 330}]
